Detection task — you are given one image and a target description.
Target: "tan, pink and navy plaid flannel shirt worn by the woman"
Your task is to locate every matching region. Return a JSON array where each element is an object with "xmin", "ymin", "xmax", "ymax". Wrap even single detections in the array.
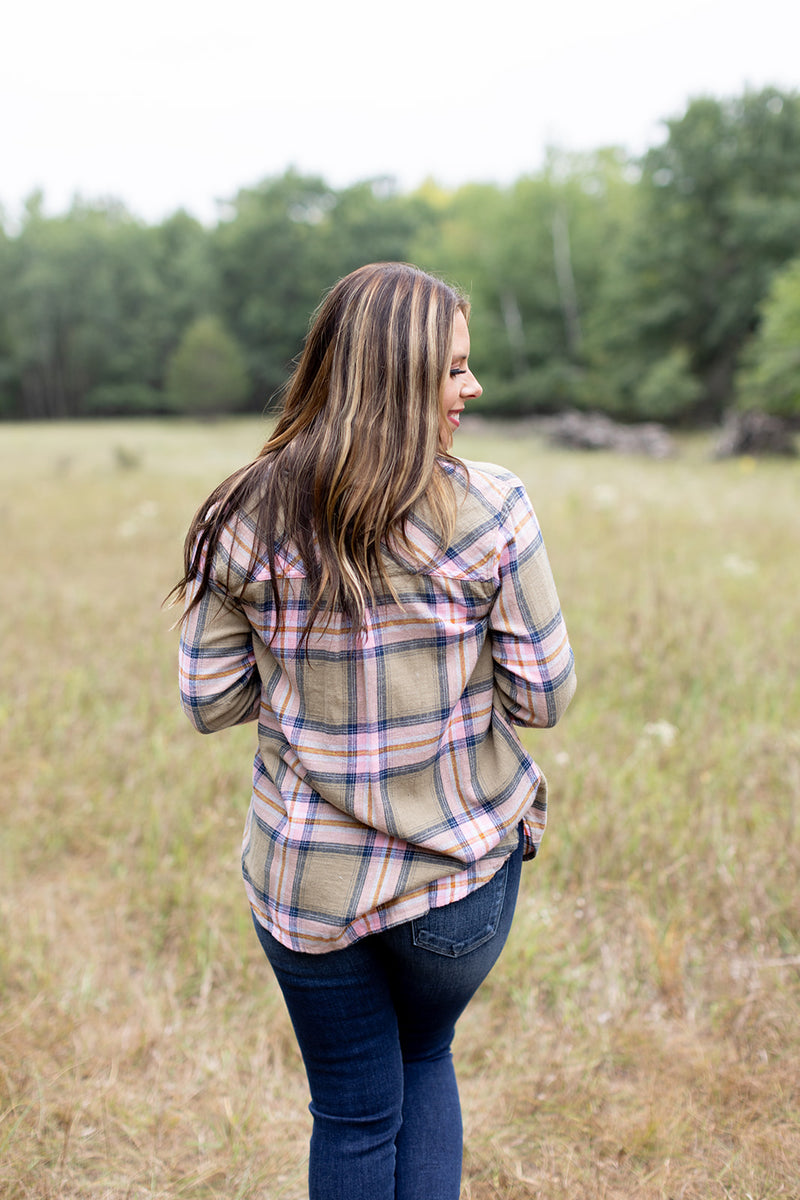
[{"xmin": 180, "ymin": 453, "xmax": 575, "ymax": 953}]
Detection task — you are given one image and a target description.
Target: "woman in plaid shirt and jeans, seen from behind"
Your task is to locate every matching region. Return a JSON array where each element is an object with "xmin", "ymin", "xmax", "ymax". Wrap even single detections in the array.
[{"xmin": 176, "ymin": 263, "xmax": 575, "ymax": 1200}]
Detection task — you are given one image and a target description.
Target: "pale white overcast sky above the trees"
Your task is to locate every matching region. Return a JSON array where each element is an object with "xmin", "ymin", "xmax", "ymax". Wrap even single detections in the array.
[{"xmin": 0, "ymin": 0, "xmax": 800, "ymax": 221}]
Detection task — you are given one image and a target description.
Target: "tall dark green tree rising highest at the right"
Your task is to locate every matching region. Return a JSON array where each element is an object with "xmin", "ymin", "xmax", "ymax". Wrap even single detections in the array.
[{"xmin": 594, "ymin": 89, "xmax": 800, "ymax": 419}]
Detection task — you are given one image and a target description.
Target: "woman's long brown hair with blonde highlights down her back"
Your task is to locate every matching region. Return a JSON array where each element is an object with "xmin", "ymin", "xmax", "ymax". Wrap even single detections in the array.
[{"xmin": 170, "ymin": 263, "xmax": 469, "ymax": 641}]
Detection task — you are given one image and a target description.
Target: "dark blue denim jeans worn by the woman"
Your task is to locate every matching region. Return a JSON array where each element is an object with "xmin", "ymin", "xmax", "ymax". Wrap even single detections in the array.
[{"xmin": 255, "ymin": 838, "xmax": 522, "ymax": 1200}]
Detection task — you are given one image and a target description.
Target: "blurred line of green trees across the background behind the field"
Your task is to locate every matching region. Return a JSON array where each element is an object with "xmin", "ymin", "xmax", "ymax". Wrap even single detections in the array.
[{"xmin": 0, "ymin": 88, "xmax": 800, "ymax": 424}]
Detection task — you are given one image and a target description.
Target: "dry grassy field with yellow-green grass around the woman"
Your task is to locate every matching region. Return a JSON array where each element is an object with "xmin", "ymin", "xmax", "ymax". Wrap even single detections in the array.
[{"xmin": 0, "ymin": 421, "xmax": 800, "ymax": 1200}]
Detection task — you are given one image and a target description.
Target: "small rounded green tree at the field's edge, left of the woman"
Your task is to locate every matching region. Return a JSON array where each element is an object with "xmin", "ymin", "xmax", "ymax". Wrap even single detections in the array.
[{"xmin": 167, "ymin": 317, "xmax": 249, "ymax": 416}]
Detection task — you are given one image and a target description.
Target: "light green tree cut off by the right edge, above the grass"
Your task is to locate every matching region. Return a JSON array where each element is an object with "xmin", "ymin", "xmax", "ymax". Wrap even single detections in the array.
[{"xmin": 736, "ymin": 258, "xmax": 800, "ymax": 416}]
